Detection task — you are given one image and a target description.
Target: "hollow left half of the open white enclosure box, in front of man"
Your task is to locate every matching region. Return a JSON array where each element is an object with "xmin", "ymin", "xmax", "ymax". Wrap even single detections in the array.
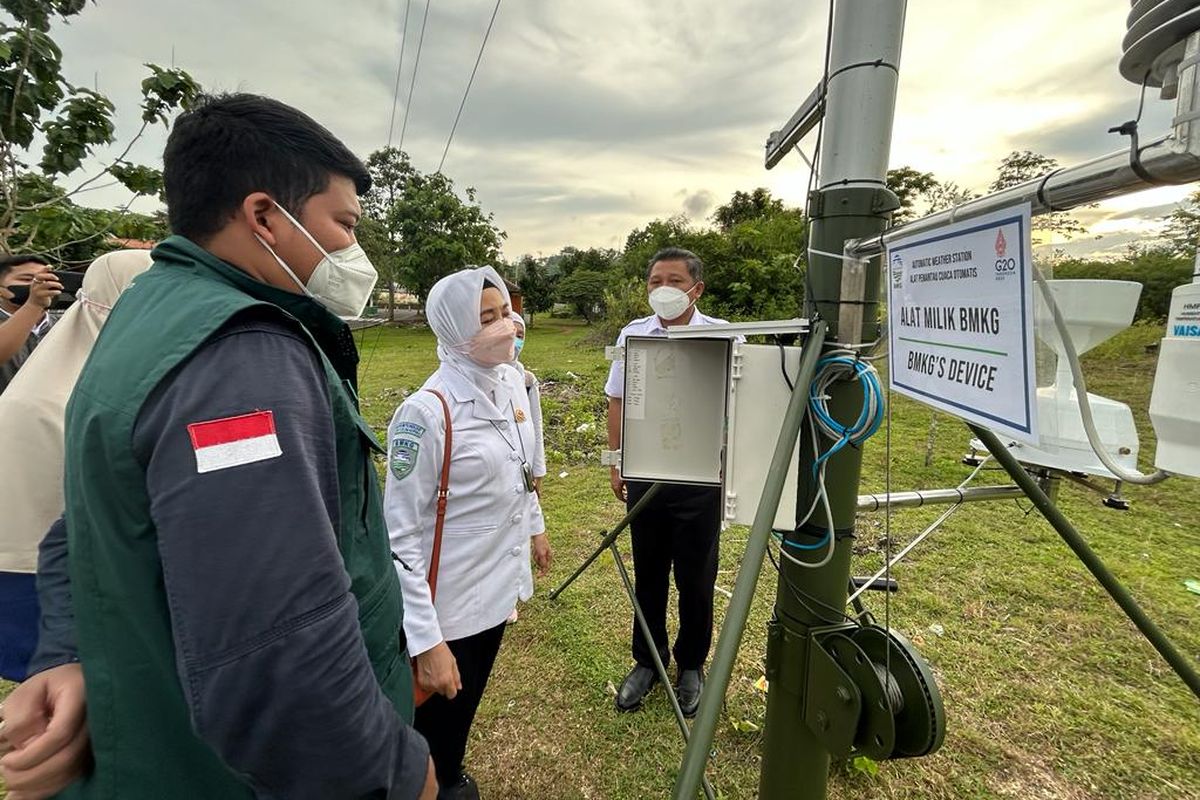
[{"xmin": 620, "ymin": 336, "xmax": 732, "ymax": 486}]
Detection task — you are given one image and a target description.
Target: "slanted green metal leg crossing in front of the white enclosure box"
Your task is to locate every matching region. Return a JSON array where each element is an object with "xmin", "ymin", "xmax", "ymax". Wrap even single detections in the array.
[{"xmin": 673, "ymin": 321, "xmax": 830, "ymax": 800}]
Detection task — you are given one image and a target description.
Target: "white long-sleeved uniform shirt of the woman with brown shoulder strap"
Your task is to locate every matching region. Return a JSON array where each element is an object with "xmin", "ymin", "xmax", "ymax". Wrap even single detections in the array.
[{"xmin": 384, "ymin": 366, "xmax": 545, "ymax": 655}]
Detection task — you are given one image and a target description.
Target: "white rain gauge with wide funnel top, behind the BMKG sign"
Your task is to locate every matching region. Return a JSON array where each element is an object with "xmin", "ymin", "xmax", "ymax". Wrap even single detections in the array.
[{"xmin": 1013, "ymin": 281, "xmax": 1141, "ymax": 477}]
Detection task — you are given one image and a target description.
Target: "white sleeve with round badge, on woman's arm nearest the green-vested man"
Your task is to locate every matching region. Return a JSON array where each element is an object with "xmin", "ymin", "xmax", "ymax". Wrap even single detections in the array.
[{"xmin": 383, "ymin": 397, "xmax": 445, "ymax": 656}]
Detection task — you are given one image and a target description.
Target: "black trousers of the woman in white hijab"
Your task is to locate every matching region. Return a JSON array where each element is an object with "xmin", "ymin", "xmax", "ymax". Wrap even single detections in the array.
[{"xmin": 413, "ymin": 622, "xmax": 505, "ymax": 787}]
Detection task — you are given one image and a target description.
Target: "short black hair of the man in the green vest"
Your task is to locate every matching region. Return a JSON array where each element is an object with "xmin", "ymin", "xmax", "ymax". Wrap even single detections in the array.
[{"xmin": 162, "ymin": 94, "xmax": 371, "ymax": 243}]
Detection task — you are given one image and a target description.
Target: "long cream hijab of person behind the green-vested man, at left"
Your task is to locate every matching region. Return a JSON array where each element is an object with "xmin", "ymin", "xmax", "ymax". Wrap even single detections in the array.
[{"xmin": 0, "ymin": 249, "xmax": 150, "ymax": 572}]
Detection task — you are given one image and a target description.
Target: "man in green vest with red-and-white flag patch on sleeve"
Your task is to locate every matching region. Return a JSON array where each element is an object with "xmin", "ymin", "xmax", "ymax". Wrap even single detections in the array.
[{"xmin": 0, "ymin": 95, "xmax": 437, "ymax": 800}]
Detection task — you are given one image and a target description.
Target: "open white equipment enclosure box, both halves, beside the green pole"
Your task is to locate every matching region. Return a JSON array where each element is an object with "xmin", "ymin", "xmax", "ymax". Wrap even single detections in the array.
[{"xmin": 620, "ymin": 337, "xmax": 800, "ymax": 530}]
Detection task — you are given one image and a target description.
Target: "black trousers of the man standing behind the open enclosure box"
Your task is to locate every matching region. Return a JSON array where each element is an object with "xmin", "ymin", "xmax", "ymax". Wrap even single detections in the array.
[{"xmin": 626, "ymin": 482, "xmax": 721, "ymax": 669}]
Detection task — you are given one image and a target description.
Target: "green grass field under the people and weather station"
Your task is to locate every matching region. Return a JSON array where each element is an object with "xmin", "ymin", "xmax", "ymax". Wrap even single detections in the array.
[{"xmin": 0, "ymin": 318, "xmax": 1200, "ymax": 800}]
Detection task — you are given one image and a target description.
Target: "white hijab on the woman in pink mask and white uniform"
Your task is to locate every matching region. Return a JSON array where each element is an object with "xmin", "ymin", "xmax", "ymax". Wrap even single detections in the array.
[{"xmin": 425, "ymin": 266, "xmax": 512, "ymax": 409}]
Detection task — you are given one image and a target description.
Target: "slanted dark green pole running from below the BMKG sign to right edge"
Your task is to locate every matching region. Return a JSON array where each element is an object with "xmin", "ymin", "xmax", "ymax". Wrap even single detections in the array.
[{"xmin": 967, "ymin": 425, "xmax": 1200, "ymax": 697}]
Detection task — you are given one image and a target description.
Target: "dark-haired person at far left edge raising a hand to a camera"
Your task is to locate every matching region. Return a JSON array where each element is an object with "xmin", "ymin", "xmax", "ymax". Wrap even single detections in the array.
[{"xmin": 0, "ymin": 255, "xmax": 62, "ymax": 393}]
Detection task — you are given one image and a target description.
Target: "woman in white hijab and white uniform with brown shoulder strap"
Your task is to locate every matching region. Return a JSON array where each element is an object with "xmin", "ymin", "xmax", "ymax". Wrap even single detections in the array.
[{"xmin": 384, "ymin": 266, "xmax": 551, "ymax": 799}]
